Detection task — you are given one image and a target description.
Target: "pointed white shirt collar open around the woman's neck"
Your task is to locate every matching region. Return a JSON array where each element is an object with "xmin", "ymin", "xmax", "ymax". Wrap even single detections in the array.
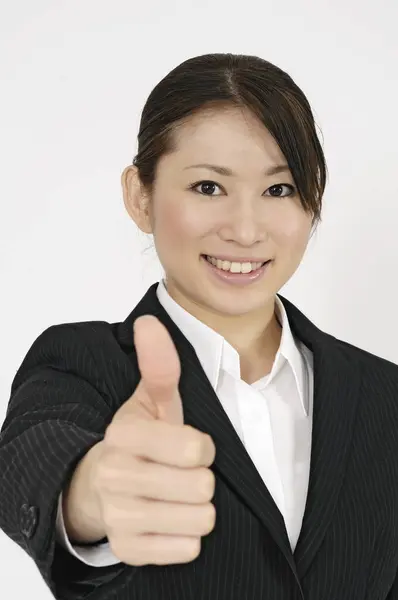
[{"xmin": 156, "ymin": 279, "xmax": 309, "ymax": 416}]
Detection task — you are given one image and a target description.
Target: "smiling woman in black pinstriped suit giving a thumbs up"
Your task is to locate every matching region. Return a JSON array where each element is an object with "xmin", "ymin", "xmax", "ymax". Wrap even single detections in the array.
[{"xmin": 0, "ymin": 54, "xmax": 398, "ymax": 600}]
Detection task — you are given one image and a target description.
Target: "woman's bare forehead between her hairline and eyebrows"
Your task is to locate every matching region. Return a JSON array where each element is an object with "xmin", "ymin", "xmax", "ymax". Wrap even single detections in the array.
[{"xmin": 169, "ymin": 108, "xmax": 283, "ymax": 170}]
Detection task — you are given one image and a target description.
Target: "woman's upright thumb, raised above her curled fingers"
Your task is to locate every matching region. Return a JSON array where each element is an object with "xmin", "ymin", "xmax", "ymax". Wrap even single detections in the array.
[{"xmin": 134, "ymin": 315, "xmax": 184, "ymax": 425}]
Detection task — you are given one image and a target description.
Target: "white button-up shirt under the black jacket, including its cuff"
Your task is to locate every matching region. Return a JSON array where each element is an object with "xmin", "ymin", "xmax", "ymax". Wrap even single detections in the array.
[{"xmin": 57, "ymin": 281, "xmax": 314, "ymax": 567}]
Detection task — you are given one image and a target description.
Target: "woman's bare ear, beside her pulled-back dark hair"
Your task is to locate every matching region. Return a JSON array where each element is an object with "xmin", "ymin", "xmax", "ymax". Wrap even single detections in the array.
[{"xmin": 121, "ymin": 165, "xmax": 152, "ymax": 233}]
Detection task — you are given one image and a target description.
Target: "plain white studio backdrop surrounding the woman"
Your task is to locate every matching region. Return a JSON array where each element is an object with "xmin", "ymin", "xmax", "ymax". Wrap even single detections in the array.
[{"xmin": 0, "ymin": 0, "xmax": 398, "ymax": 600}]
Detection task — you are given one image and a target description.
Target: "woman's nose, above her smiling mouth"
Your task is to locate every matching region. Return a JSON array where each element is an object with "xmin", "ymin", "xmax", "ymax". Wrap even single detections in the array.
[{"xmin": 219, "ymin": 202, "xmax": 267, "ymax": 246}]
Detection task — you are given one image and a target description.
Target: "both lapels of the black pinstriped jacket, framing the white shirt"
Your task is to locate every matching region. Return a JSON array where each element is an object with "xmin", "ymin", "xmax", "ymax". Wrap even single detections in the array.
[{"xmin": 120, "ymin": 284, "xmax": 359, "ymax": 587}]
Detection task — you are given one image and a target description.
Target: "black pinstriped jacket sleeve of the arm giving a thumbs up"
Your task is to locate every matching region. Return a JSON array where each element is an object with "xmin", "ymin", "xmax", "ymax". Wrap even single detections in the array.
[{"xmin": 0, "ymin": 324, "xmax": 126, "ymax": 600}]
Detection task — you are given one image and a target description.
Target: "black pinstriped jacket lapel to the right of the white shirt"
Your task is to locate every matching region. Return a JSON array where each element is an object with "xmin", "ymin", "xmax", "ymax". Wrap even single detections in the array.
[{"xmin": 280, "ymin": 296, "xmax": 360, "ymax": 579}]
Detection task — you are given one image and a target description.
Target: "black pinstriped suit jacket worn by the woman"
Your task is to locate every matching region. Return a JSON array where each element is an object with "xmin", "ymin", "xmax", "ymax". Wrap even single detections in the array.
[{"xmin": 0, "ymin": 284, "xmax": 398, "ymax": 600}]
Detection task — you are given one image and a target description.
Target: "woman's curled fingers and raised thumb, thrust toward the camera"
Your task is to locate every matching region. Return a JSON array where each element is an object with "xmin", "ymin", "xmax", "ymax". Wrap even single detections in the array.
[{"xmin": 92, "ymin": 315, "xmax": 215, "ymax": 566}]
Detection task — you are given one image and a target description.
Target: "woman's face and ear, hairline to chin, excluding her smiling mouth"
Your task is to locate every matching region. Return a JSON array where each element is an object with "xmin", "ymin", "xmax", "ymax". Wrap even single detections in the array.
[{"xmin": 122, "ymin": 109, "xmax": 312, "ymax": 332}]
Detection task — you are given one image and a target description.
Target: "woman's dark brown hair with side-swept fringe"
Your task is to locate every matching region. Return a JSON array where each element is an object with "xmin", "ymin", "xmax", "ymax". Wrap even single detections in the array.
[{"xmin": 133, "ymin": 54, "xmax": 327, "ymax": 223}]
